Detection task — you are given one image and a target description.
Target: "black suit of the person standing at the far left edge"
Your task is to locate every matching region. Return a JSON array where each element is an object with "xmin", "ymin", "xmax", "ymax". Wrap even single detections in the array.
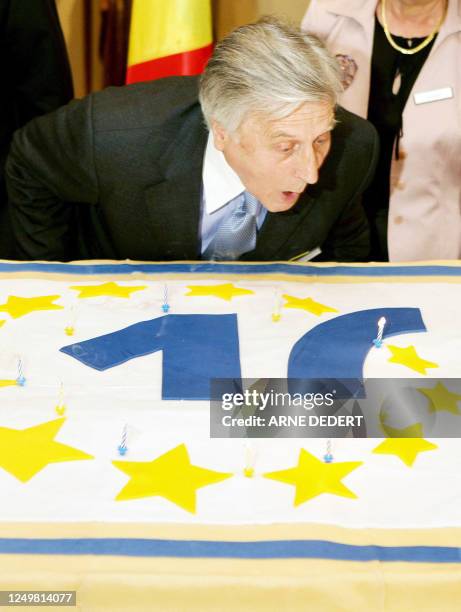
[{"xmin": 0, "ymin": 0, "xmax": 73, "ymax": 258}]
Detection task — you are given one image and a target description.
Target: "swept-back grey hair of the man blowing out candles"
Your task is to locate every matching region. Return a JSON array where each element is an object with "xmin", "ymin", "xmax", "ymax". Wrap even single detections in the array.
[{"xmin": 199, "ymin": 17, "xmax": 342, "ymax": 131}]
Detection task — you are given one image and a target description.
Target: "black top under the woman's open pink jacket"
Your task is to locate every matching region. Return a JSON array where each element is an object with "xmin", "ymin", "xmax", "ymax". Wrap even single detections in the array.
[{"xmin": 364, "ymin": 17, "xmax": 436, "ymax": 261}]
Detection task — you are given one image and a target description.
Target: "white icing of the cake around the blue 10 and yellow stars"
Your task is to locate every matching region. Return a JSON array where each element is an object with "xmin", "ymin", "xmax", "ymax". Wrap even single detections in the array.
[{"xmin": 0, "ymin": 260, "xmax": 461, "ymax": 527}]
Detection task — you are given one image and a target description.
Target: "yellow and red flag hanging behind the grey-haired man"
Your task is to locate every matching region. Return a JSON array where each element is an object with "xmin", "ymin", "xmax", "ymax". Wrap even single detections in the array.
[{"xmin": 126, "ymin": 0, "xmax": 213, "ymax": 83}]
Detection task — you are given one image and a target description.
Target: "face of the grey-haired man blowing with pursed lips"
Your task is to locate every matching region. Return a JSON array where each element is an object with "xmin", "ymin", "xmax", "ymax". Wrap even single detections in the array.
[{"xmin": 212, "ymin": 102, "xmax": 334, "ymax": 212}]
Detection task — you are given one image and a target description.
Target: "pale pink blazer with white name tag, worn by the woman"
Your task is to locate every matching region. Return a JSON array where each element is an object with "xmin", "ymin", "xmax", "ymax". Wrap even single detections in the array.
[{"xmin": 302, "ymin": 0, "xmax": 461, "ymax": 261}]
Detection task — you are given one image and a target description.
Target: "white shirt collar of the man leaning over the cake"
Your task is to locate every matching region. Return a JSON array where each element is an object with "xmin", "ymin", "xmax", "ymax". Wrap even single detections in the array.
[{"xmin": 202, "ymin": 132, "xmax": 245, "ymax": 215}]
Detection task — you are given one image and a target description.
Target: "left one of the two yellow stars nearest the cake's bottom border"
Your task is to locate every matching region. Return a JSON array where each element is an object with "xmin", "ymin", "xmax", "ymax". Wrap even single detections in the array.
[{"xmin": 112, "ymin": 444, "xmax": 233, "ymax": 514}]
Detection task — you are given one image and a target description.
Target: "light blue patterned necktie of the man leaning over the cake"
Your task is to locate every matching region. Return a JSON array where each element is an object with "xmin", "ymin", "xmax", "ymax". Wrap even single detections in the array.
[{"xmin": 205, "ymin": 191, "xmax": 259, "ymax": 261}]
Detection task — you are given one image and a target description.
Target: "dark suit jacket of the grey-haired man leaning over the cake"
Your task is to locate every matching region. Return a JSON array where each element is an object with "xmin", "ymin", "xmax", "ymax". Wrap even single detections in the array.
[{"xmin": 7, "ymin": 77, "xmax": 377, "ymax": 261}]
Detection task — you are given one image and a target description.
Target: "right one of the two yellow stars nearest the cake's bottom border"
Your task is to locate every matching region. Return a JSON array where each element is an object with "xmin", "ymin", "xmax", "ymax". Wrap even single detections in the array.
[{"xmin": 264, "ymin": 448, "xmax": 363, "ymax": 506}]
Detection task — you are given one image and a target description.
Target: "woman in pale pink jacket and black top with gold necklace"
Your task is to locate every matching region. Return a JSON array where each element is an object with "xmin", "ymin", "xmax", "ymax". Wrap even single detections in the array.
[{"xmin": 302, "ymin": 0, "xmax": 461, "ymax": 261}]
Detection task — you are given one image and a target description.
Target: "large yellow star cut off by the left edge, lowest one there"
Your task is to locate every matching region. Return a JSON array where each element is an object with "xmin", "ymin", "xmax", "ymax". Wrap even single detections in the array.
[{"xmin": 0, "ymin": 418, "xmax": 94, "ymax": 482}]
